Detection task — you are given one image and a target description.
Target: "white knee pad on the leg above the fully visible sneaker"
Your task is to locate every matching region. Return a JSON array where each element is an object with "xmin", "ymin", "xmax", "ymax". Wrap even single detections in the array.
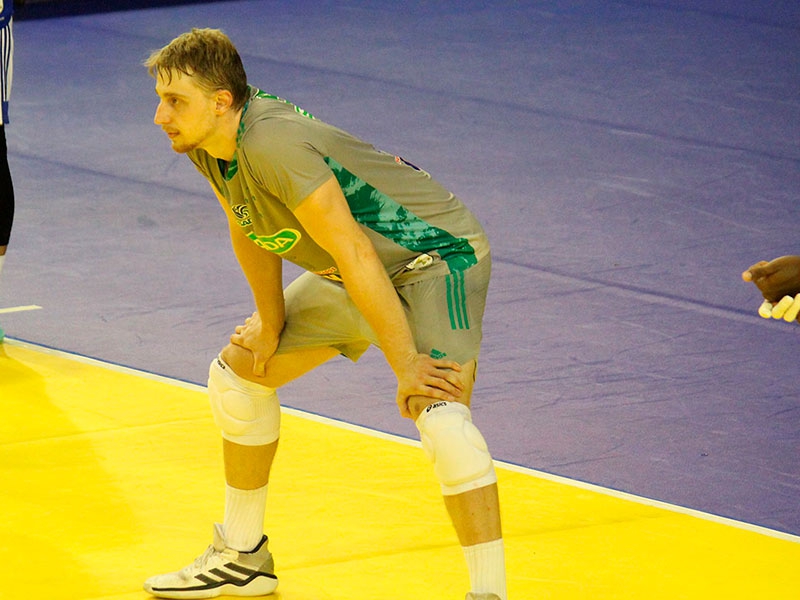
[{"xmin": 208, "ymin": 357, "xmax": 281, "ymax": 446}]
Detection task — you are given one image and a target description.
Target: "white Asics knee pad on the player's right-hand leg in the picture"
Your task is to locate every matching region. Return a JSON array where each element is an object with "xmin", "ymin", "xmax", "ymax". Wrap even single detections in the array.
[{"xmin": 417, "ymin": 402, "xmax": 497, "ymax": 496}]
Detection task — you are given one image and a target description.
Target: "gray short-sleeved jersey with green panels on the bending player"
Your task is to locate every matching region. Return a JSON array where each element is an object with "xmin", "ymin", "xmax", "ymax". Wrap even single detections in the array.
[{"xmin": 189, "ymin": 87, "xmax": 489, "ymax": 285}]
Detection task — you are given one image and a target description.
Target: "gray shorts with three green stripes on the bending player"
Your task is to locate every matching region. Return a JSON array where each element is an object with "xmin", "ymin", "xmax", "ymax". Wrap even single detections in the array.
[{"xmin": 276, "ymin": 256, "xmax": 492, "ymax": 363}]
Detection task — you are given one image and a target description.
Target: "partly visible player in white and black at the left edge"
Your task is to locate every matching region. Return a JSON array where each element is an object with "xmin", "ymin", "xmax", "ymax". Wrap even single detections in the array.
[{"xmin": 0, "ymin": 0, "xmax": 14, "ymax": 342}]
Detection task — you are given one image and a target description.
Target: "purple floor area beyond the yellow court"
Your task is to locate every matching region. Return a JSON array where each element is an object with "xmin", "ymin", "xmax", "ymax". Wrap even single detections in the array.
[{"xmin": 0, "ymin": 0, "xmax": 800, "ymax": 534}]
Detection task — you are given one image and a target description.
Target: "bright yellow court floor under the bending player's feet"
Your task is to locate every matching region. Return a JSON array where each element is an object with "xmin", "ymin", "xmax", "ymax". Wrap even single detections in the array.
[{"xmin": 0, "ymin": 340, "xmax": 800, "ymax": 600}]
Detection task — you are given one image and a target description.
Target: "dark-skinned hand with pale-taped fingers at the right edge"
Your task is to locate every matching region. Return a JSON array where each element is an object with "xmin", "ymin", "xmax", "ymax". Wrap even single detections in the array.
[{"xmin": 742, "ymin": 256, "xmax": 800, "ymax": 323}]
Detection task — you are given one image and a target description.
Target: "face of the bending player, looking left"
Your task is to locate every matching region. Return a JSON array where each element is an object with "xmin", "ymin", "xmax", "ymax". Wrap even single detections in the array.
[{"xmin": 153, "ymin": 71, "xmax": 216, "ymax": 154}]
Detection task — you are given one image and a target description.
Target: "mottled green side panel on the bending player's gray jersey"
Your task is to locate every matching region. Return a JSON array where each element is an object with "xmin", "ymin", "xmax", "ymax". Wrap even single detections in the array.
[{"xmin": 325, "ymin": 156, "xmax": 478, "ymax": 272}]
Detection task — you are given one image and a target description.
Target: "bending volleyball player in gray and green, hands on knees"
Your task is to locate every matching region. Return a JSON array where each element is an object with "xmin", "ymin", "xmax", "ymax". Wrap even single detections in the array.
[{"xmin": 145, "ymin": 29, "xmax": 506, "ymax": 600}]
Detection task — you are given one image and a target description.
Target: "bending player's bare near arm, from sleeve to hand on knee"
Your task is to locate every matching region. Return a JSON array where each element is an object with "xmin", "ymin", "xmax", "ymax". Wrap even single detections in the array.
[{"xmin": 294, "ymin": 176, "xmax": 462, "ymax": 417}]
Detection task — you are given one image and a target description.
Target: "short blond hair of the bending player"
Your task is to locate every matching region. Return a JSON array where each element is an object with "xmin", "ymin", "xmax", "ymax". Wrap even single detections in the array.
[{"xmin": 144, "ymin": 28, "xmax": 248, "ymax": 109}]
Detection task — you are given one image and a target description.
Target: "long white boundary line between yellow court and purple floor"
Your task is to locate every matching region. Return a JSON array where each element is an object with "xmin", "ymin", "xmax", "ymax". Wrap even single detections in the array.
[{"xmin": 7, "ymin": 337, "xmax": 800, "ymax": 544}]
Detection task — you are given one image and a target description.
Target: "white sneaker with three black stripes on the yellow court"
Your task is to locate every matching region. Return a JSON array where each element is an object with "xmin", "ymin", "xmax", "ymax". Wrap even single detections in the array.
[{"xmin": 144, "ymin": 523, "xmax": 278, "ymax": 598}]
